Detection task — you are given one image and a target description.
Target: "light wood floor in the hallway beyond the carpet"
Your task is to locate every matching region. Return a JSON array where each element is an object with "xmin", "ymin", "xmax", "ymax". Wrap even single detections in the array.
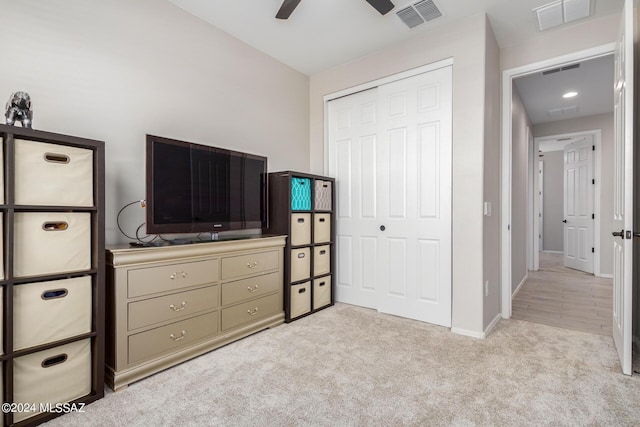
[{"xmin": 512, "ymin": 252, "xmax": 613, "ymax": 335}]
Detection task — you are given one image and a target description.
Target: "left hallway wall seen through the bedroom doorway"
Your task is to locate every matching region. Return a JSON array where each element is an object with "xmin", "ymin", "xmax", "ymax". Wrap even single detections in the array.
[{"xmin": 511, "ymin": 84, "xmax": 533, "ymax": 293}]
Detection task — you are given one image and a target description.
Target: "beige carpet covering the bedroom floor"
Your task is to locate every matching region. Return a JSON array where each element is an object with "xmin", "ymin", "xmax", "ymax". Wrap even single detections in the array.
[{"xmin": 48, "ymin": 304, "xmax": 640, "ymax": 426}]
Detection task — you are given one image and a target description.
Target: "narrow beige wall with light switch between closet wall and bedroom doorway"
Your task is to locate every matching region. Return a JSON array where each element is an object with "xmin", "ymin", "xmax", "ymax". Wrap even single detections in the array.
[{"xmin": 482, "ymin": 20, "xmax": 501, "ymax": 330}]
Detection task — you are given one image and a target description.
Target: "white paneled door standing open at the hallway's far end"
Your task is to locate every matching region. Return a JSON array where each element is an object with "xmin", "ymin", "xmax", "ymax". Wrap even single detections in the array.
[{"xmin": 563, "ymin": 135, "xmax": 594, "ymax": 273}]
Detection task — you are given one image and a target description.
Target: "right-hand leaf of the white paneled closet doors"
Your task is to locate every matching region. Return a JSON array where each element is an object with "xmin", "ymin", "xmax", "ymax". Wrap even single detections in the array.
[{"xmin": 378, "ymin": 67, "xmax": 452, "ymax": 326}]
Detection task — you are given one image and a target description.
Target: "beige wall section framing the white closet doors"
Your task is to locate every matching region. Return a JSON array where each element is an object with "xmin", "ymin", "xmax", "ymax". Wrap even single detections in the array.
[{"xmin": 310, "ymin": 15, "xmax": 486, "ymax": 334}]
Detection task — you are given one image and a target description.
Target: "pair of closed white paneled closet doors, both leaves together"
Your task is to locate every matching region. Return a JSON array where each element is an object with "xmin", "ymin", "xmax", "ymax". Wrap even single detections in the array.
[{"xmin": 328, "ymin": 66, "xmax": 452, "ymax": 326}]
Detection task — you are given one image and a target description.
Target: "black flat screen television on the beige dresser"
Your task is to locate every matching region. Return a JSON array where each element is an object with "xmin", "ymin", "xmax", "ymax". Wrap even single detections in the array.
[{"xmin": 146, "ymin": 135, "xmax": 268, "ymax": 234}]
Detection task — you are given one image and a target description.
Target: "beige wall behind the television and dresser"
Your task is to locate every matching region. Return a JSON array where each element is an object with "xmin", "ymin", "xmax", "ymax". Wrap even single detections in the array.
[{"xmin": 0, "ymin": 0, "xmax": 309, "ymax": 243}]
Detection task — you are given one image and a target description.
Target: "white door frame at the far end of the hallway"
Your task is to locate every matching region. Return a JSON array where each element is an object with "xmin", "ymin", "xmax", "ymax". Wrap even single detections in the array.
[{"xmin": 528, "ymin": 129, "xmax": 611, "ymax": 277}]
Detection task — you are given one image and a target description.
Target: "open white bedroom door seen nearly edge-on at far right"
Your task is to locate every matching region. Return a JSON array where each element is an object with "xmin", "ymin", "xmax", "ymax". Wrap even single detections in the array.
[{"xmin": 613, "ymin": 0, "xmax": 634, "ymax": 375}]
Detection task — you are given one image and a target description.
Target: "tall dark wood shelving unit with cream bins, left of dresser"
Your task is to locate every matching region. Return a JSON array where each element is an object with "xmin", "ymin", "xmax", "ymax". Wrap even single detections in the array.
[{"xmin": 0, "ymin": 125, "xmax": 105, "ymax": 426}]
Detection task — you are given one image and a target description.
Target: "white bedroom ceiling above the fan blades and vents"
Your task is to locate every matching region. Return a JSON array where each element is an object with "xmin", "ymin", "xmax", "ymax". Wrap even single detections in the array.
[{"xmin": 169, "ymin": 0, "xmax": 623, "ymax": 75}]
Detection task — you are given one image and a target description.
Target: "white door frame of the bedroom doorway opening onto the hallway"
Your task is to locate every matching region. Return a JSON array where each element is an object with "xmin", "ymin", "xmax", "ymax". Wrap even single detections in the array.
[{"xmin": 500, "ymin": 43, "xmax": 615, "ymax": 319}]
